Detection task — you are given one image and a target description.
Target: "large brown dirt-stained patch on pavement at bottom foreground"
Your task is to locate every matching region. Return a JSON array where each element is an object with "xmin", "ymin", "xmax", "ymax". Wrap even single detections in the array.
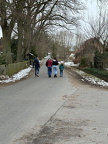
[{"xmin": 32, "ymin": 119, "xmax": 88, "ymax": 144}]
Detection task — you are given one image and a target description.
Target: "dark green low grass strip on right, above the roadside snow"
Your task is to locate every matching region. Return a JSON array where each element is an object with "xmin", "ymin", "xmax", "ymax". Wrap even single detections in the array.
[{"xmin": 82, "ymin": 68, "xmax": 108, "ymax": 82}]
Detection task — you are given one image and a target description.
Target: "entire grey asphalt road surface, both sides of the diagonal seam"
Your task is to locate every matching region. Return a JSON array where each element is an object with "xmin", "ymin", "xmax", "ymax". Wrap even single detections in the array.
[{"xmin": 0, "ymin": 65, "xmax": 108, "ymax": 144}]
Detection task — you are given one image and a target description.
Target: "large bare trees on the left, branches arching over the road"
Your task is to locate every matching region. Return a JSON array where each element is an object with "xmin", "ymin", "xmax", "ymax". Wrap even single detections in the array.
[{"xmin": 0, "ymin": 0, "xmax": 83, "ymax": 63}]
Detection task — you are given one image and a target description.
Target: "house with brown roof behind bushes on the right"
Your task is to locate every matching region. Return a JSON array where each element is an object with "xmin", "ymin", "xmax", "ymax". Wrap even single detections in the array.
[{"xmin": 75, "ymin": 38, "xmax": 103, "ymax": 64}]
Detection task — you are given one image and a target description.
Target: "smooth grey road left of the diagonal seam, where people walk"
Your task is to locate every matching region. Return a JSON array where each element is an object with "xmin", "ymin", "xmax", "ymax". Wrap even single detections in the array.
[{"xmin": 0, "ymin": 63, "xmax": 76, "ymax": 144}]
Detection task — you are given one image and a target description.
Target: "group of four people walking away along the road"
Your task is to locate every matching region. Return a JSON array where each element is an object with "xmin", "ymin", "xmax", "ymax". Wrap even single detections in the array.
[{"xmin": 33, "ymin": 57, "xmax": 64, "ymax": 78}]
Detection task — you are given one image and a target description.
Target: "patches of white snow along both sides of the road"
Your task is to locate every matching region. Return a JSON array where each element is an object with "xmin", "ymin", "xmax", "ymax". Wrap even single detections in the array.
[{"xmin": 0, "ymin": 61, "xmax": 108, "ymax": 87}]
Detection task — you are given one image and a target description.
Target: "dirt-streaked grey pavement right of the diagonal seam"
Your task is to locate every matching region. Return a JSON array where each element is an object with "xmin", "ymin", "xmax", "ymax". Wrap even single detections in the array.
[{"xmin": 31, "ymin": 70, "xmax": 108, "ymax": 144}]
